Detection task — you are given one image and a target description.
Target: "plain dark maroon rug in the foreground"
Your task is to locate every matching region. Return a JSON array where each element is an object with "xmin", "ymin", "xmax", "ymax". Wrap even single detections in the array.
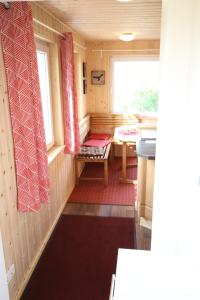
[{"xmin": 21, "ymin": 215, "xmax": 135, "ymax": 300}]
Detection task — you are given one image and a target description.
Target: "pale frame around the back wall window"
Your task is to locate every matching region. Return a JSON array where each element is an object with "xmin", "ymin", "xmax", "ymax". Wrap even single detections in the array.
[{"xmin": 109, "ymin": 54, "xmax": 160, "ymax": 115}]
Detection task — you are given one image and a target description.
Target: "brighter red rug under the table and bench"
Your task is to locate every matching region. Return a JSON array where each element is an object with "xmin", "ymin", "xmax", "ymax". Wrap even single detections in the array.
[{"xmin": 68, "ymin": 158, "xmax": 137, "ymax": 205}]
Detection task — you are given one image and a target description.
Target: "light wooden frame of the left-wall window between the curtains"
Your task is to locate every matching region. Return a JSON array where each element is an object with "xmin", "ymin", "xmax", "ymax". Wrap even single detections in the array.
[{"xmin": 36, "ymin": 40, "xmax": 55, "ymax": 151}]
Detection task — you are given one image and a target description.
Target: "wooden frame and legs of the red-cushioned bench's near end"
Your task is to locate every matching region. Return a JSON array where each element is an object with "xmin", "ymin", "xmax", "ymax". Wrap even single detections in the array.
[{"xmin": 75, "ymin": 143, "xmax": 111, "ymax": 186}]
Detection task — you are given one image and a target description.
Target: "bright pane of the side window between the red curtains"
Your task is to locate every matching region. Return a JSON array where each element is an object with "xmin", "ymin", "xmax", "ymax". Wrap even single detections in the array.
[{"xmin": 37, "ymin": 44, "xmax": 54, "ymax": 150}]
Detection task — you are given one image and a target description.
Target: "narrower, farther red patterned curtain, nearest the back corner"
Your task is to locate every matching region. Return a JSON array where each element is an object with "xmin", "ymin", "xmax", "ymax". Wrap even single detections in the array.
[{"xmin": 60, "ymin": 32, "xmax": 80, "ymax": 154}]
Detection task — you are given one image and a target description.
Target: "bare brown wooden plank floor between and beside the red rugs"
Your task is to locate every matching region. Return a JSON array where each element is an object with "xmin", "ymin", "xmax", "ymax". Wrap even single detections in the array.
[{"xmin": 63, "ymin": 203, "xmax": 151, "ymax": 250}]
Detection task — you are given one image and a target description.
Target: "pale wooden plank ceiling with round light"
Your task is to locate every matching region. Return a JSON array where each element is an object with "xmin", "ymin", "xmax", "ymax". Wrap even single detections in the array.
[{"xmin": 40, "ymin": 0, "xmax": 161, "ymax": 41}]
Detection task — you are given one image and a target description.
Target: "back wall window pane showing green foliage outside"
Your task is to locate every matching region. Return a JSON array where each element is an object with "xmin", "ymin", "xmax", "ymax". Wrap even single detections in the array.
[{"xmin": 112, "ymin": 58, "xmax": 159, "ymax": 113}]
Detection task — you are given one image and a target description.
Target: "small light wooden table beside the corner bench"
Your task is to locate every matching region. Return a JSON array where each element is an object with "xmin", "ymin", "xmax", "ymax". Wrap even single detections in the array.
[{"xmin": 113, "ymin": 126, "xmax": 137, "ymax": 183}]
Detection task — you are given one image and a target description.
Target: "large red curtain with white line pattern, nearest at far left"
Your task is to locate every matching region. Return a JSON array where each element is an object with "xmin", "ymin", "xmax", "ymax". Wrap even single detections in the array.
[{"xmin": 0, "ymin": 2, "xmax": 49, "ymax": 212}]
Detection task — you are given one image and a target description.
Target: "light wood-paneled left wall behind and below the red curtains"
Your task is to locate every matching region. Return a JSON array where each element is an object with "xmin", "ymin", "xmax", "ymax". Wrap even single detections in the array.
[{"xmin": 0, "ymin": 5, "xmax": 89, "ymax": 300}]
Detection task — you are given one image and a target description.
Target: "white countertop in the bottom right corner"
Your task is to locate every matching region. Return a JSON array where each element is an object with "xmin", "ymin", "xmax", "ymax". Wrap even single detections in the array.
[{"xmin": 113, "ymin": 249, "xmax": 200, "ymax": 300}]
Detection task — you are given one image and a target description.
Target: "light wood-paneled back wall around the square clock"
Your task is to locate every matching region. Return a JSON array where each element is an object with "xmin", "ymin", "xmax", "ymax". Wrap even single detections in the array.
[{"xmin": 86, "ymin": 40, "xmax": 160, "ymax": 113}]
